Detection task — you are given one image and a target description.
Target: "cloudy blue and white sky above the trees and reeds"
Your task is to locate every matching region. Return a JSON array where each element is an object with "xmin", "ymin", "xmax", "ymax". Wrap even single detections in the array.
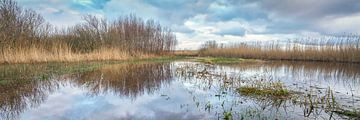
[{"xmin": 17, "ymin": 0, "xmax": 360, "ymax": 50}]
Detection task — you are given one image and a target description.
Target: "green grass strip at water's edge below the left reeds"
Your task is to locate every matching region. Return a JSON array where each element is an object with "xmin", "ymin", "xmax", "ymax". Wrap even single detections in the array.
[{"xmin": 0, "ymin": 56, "xmax": 186, "ymax": 85}]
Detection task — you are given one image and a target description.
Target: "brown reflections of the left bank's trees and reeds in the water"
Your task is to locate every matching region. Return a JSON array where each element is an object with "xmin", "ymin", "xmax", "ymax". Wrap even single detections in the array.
[{"xmin": 0, "ymin": 63, "xmax": 172, "ymax": 119}]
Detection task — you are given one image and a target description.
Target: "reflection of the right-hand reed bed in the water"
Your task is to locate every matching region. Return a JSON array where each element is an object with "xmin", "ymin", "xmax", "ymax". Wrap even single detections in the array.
[{"xmin": 225, "ymin": 62, "xmax": 360, "ymax": 95}]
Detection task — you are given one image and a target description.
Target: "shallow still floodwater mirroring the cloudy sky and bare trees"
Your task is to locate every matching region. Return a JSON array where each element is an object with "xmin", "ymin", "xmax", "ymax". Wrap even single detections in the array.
[{"xmin": 0, "ymin": 61, "xmax": 360, "ymax": 120}]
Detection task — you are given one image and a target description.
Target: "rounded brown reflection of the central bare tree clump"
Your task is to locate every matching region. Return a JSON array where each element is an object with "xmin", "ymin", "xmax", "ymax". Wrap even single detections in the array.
[{"xmin": 68, "ymin": 63, "xmax": 172, "ymax": 98}]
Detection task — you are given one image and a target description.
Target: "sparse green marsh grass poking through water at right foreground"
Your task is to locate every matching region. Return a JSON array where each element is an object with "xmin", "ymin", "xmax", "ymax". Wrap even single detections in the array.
[{"xmin": 176, "ymin": 63, "xmax": 359, "ymax": 119}]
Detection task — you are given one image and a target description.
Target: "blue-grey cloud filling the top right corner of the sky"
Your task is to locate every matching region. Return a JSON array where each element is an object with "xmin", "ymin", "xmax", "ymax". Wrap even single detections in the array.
[{"xmin": 252, "ymin": 0, "xmax": 360, "ymax": 19}]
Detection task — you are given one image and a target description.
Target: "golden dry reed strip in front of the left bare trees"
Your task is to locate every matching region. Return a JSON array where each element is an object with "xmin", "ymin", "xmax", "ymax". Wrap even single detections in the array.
[{"xmin": 0, "ymin": 47, "xmax": 156, "ymax": 64}]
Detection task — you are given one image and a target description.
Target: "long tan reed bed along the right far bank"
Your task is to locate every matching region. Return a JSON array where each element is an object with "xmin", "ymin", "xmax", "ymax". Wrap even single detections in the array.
[{"xmin": 199, "ymin": 35, "xmax": 360, "ymax": 63}]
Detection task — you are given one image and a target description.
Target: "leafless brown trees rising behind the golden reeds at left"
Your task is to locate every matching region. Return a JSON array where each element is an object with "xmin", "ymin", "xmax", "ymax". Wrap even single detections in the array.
[{"xmin": 0, "ymin": 0, "xmax": 177, "ymax": 58}]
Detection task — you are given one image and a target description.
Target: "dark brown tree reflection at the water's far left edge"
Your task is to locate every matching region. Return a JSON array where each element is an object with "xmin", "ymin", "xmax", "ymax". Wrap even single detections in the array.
[{"xmin": 0, "ymin": 65, "xmax": 57, "ymax": 119}]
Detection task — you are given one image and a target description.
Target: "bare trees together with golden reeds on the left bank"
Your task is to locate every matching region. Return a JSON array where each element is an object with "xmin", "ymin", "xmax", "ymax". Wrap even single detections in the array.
[{"xmin": 0, "ymin": 0, "xmax": 176, "ymax": 64}]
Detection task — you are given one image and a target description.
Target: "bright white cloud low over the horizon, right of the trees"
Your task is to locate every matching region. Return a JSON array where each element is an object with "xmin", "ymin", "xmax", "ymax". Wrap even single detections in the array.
[{"xmin": 176, "ymin": 14, "xmax": 280, "ymax": 49}]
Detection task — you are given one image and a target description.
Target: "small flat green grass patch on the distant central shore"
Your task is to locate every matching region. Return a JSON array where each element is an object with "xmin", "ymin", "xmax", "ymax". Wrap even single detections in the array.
[{"xmin": 195, "ymin": 57, "xmax": 252, "ymax": 64}]
